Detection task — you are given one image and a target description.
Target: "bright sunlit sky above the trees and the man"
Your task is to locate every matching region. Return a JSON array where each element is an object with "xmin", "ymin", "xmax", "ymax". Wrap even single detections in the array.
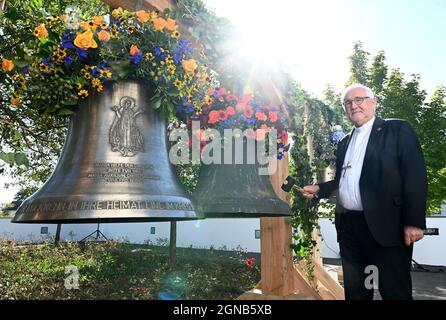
[{"xmin": 205, "ymin": 0, "xmax": 446, "ymax": 95}]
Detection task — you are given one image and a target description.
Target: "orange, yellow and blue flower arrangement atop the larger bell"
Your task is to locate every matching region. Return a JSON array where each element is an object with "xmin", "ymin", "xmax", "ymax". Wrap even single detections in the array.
[{"xmin": 2, "ymin": 8, "xmax": 210, "ymax": 117}]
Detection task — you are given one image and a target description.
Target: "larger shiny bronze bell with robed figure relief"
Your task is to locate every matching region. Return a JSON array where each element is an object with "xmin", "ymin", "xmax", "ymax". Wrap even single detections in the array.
[{"xmin": 13, "ymin": 81, "xmax": 197, "ymax": 223}]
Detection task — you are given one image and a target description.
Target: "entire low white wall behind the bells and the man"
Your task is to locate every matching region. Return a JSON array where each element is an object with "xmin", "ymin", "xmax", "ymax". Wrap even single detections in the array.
[{"xmin": 0, "ymin": 216, "xmax": 446, "ymax": 266}]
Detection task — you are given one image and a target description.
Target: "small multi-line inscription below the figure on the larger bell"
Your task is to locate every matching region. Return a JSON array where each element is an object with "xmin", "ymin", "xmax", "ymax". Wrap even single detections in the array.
[{"xmin": 86, "ymin": 162, "xmax": 160, "ymax": 183}]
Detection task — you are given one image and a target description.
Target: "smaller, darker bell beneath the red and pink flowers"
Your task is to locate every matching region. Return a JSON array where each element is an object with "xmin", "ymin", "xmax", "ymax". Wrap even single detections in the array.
[{"xmin": 193, "ymin": 138, "xmax": 291, "ymax": 218}]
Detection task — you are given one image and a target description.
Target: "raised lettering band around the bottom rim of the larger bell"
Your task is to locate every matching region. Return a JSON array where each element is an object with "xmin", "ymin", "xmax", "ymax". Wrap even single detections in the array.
[{"xmin": 22, "ymin": 200, "xmax": 194, "ymax": 213}]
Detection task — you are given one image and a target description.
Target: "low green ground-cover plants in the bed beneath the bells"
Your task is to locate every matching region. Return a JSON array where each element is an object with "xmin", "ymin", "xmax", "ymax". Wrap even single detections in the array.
[{"xmin": 0, "ymin": 241, "xmax": 260, "ymax": 300}]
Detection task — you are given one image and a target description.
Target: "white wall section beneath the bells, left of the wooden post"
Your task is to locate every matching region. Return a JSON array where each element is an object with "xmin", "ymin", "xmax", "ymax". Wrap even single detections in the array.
[{"xmin": 0, "ymin": 218, "xmax": 260, "ymax": 252}]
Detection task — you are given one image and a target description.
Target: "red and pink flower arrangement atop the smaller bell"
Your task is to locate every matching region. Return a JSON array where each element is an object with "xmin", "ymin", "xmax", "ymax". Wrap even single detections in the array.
[{"xmin": 191, "ymin": 87, "xmax": 289, "ymax": 160}]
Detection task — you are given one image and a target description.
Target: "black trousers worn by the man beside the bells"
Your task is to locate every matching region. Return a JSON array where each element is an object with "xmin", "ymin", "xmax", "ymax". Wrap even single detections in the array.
[{"xmin": 338, "ymin": 211, "xmax": 413, "ymax": 300}]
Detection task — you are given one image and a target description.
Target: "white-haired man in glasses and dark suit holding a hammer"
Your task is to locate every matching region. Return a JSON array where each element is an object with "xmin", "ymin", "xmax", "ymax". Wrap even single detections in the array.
[{"xmin": 302, "ymin": 84, "xmax": 427, "ymax": 300}]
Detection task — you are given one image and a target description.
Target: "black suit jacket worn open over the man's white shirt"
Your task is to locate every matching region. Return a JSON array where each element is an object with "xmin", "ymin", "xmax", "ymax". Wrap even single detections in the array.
[{"xmin": 319, "ymin": 117, "xmax": 427, "ymax": 246}]
